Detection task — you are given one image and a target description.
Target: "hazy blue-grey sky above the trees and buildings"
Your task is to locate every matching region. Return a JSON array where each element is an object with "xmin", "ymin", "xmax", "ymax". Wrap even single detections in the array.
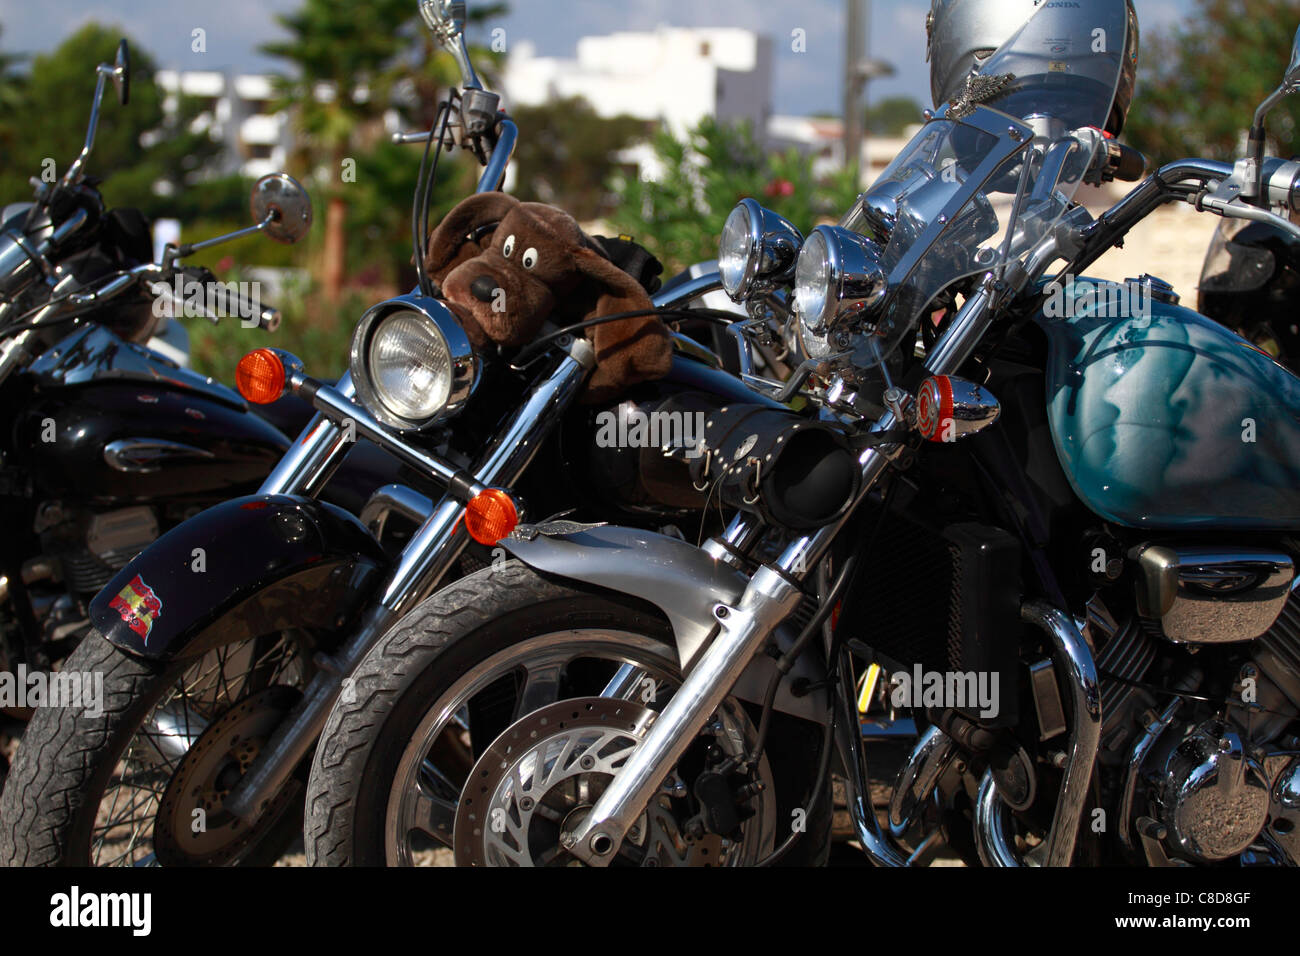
[{"xmin": 0, "ymin": 0, "xmax": 1192, "ymax": 114}]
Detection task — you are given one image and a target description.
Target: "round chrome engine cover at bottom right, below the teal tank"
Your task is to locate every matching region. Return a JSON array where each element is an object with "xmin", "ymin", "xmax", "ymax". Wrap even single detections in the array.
[{"xmin": 1158, "ymin": 721, "xmax": 1270, "ymax": 862}]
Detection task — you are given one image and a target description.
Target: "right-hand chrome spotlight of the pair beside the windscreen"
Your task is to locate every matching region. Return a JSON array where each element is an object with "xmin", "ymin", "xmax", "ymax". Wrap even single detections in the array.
[{"xmin": 794, "ymin": 226, "xmax": 889, "ymax": 336}]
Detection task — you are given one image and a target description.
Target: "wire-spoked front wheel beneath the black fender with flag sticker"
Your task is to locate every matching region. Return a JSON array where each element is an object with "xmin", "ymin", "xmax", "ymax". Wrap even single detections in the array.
[{"xmin": 0, "ymin": 632, "xmax": 309, "ymax": 866}]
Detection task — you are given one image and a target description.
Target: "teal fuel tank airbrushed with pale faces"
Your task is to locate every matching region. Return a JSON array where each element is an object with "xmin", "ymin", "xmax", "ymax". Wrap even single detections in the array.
[{"xmin": 1036, "ymin": 278, "xmax": 1300, "ymax": 531}]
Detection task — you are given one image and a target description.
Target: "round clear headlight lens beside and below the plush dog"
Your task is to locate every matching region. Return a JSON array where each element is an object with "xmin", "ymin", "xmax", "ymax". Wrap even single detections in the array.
[{"xmin": 369, "ymin": 312, "xmax": 451, "ymax": 421}]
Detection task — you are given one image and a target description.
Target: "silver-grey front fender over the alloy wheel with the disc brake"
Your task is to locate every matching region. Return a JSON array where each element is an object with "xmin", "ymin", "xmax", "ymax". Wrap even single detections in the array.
[{"xmin": 501, "ymin": 525, "xmax": 828, "ymax": 723}]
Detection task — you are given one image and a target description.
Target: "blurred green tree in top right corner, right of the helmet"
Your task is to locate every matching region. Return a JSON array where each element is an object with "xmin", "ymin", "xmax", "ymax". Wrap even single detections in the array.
[{"xmin": 1125, "ymin": 0, "xmax": 1300, "ymax": 164}]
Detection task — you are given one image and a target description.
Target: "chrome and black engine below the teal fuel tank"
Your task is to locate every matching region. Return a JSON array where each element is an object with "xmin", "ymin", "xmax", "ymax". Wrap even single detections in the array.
[{"xmin": 1089, "ymin": 581, "xmax": 1300, "ymax": 866}]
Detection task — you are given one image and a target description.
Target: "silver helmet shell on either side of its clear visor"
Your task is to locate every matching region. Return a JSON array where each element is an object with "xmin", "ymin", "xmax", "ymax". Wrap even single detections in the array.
[{"xmin": 926, "ymin": 0, "xmax": 1139, "ymax": 137}]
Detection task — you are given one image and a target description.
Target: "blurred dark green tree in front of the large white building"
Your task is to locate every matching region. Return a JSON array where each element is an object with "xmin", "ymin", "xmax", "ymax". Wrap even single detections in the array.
[{"xmin": 515, "ymin": 96, "xmax": 645, "ymax": 222}]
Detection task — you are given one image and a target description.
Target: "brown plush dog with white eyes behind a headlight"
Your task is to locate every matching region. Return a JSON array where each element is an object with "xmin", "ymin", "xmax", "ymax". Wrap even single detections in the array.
[{"xmin": 425, "ymin": 193, "xmax": 672, "ymax": 402}]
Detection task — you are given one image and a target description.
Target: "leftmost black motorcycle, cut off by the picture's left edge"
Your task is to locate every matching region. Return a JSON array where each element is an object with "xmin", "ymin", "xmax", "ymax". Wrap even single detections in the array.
[{"xmin": 0, "ymin": 40, "xmax": 393, "ymax": 769}]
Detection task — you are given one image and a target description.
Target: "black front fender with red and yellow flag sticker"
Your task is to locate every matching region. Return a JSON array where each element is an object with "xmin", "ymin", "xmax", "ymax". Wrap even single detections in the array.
[{"xmin": 90, "ymin": 494, "xmax": 389, "ymax": 661}]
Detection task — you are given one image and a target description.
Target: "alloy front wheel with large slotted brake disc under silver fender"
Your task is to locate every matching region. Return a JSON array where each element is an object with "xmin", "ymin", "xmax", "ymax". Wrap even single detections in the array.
[{"xmin": 304, "ymin": 562, "xmax": 829, "ymax": 866}]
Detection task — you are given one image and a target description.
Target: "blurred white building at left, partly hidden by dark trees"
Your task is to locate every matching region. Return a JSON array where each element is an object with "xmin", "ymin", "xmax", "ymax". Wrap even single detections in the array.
[{"xmin": 156, "ymin": 70, "xmax": 293, "ymax": 178}]
